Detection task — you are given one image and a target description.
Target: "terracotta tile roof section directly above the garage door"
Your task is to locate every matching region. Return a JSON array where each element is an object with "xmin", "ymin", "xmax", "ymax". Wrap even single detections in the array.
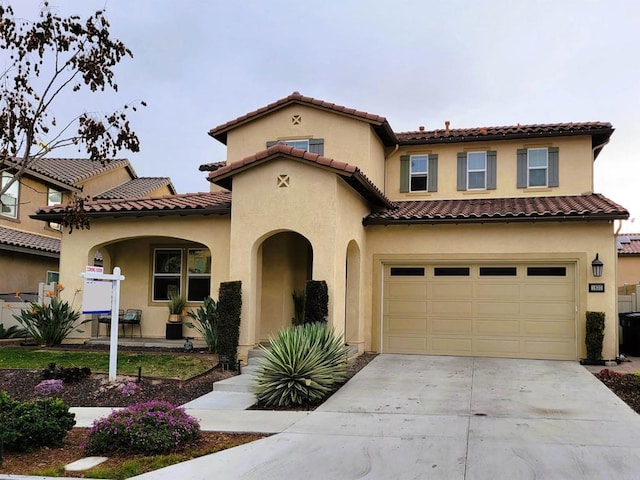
[{"xmin": 363, "ymin": 194, "xmax": 629, "ymax": 225}]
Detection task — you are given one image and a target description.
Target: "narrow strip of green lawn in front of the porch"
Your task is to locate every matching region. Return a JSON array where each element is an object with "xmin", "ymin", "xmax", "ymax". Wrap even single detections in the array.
[{"xmin": 0, "ymin": 347, "xmax": 211, "ymax": 380}]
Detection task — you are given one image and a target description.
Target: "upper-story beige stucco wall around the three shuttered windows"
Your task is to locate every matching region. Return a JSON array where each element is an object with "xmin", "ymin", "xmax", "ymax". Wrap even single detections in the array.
[{"xmin": 386, "ymin": 136, "xmax": 593, "ymax": 200}]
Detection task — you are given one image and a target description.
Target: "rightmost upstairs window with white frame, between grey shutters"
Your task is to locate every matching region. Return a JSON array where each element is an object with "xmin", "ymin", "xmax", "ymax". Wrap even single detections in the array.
[{"xmin": 517, "ymin": 147, "xmax": 560, "ymax": 188}]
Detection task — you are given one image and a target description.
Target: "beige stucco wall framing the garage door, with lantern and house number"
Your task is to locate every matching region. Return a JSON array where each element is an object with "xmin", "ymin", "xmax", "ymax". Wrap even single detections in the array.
[{"xmin": 365, "ymin": 222, "xmax": 618, "ymax": 358}]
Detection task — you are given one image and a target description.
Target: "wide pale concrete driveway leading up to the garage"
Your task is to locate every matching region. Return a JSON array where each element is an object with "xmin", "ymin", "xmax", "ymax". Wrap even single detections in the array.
[{"xmin": 137, "ymin": 355, "xmax": 640, "ymax": 480}]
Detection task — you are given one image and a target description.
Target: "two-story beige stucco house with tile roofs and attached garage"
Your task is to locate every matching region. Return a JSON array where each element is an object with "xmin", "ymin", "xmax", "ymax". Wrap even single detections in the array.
[{"xmin": 34, "ymin": 92, "xmax": 628, "ymax": 360}]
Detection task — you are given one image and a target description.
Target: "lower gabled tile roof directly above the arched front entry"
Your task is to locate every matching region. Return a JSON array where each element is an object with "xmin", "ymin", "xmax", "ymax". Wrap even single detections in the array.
[{"xmin": 208, "ymin": 143, "xmax": 391, "ymax": 207}]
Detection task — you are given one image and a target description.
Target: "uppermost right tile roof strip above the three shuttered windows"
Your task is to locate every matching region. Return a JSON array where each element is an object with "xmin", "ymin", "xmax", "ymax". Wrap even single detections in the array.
[{"xmin": 396, "ymin": 122, "xmax": 613, "ymax": 158}]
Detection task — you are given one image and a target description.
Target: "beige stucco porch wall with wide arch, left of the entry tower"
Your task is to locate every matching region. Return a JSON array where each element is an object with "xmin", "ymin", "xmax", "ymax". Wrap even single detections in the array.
[{"xmin": 60, "ymin": 216, "xmax": 229, "ymax": 337}]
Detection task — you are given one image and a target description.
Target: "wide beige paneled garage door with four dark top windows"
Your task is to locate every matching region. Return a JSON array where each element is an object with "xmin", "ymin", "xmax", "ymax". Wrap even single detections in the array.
[{"xmin": 382, "ymin": 264, "xmax": 577, "ymax": 360}]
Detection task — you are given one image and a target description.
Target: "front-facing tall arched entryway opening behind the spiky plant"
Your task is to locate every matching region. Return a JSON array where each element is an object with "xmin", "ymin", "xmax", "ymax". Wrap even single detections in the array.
[{"xmin": 257, "ymin": 232, "xmax": 313, "ymax": 342}]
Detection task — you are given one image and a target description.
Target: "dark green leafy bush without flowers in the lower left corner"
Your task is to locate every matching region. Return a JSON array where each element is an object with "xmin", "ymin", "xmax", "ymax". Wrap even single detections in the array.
[{"xmin": 0, "ymin": 392, "xmax": 76, "ymax": 452}]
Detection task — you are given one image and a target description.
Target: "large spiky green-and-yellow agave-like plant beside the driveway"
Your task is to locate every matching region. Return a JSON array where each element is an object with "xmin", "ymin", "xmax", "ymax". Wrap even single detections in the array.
[{"xmin": 255, "ymin": 323, "xmax": 348, "ymax": 407}]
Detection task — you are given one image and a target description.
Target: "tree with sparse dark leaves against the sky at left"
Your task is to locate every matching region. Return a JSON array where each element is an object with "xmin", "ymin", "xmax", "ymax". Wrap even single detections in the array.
[{"xmin": 0, "ymin": 0, "xmax": 145, "ymax": 228}]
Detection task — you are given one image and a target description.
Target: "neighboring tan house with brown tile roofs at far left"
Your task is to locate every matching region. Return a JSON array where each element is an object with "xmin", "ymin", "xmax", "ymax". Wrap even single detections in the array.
[{"xmin": 0, "ymin": 158, "xmax": 175, "ymax": 300}]
